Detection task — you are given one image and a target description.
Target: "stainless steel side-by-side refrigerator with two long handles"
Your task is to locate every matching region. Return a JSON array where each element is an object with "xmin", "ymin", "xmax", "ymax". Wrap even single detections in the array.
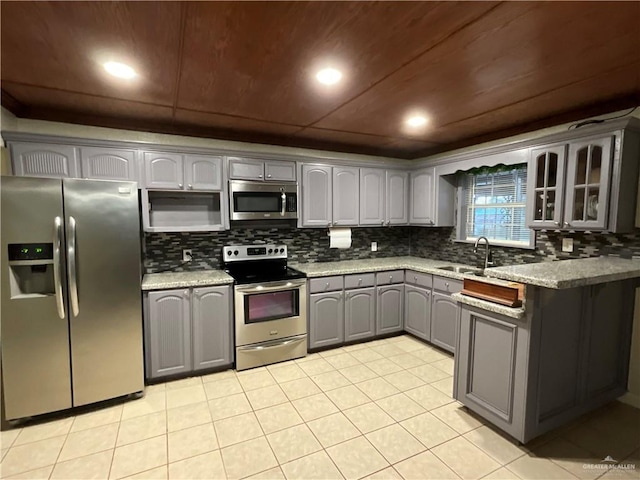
[{"xmin": 0, "ymin": 177, "xmax": 144, "ymax": 420}]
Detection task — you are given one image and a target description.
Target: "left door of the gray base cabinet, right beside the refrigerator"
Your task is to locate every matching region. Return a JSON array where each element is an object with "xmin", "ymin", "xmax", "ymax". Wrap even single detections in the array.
[{"xmin": 145, "ymin": 289, "xmax": 192, "ymax": 378}]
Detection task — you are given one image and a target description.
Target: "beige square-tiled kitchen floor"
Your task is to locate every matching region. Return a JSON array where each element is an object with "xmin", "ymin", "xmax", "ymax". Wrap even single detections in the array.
[{"xmin": 1, "ymin": 336, "xmax": 640, "ymax": 480}]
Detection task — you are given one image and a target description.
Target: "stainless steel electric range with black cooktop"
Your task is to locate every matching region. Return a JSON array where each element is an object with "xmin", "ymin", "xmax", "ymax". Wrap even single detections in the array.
[{"xmin": 222, "ymin": 245, "xmax": 307, "ymax": 370}]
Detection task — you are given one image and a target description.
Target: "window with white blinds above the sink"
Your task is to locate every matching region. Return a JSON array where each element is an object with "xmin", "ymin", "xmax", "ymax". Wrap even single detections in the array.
[{"xmin": 458, "ymin": 163, "xmax": 535, "ymax": 248}]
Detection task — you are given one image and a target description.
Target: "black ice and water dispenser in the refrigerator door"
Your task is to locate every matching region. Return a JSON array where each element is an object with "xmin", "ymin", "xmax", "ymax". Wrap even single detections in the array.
[{"xmin": 8, "ymin": 243, "xmax": 55, "ymax": 299}]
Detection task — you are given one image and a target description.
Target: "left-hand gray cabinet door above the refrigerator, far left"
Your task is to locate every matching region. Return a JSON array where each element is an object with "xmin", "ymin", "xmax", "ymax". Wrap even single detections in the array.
[{"xmin": 10, "ymin": 143, "xmax": 80, "ymax": 178}]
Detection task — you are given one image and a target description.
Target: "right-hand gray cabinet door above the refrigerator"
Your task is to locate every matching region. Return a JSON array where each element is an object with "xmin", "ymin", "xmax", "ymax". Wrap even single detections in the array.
[{"xmin": 80, "ymin": 147, "xmax": 138, "ymax": 182}]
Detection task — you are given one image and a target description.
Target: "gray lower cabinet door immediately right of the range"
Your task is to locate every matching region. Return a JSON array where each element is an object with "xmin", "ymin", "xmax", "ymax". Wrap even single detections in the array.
[{"xmin": 309, "ymin": 290, "xmax": 344, "ymax": 348}]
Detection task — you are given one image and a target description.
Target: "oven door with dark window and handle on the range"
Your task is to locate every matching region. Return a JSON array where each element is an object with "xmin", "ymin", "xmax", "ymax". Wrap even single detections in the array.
[{"xmin": 234, "ymin": 279, "xmax": 307, "ymax": 346}]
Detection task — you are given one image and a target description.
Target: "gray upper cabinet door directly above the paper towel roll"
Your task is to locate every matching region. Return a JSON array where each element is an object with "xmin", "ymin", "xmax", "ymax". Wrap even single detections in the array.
[{"xmin": 333, "ymin": 167, "xmax": 360, "ymax": 226}]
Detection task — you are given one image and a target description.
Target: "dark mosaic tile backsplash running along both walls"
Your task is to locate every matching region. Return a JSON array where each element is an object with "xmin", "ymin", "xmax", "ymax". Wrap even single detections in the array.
[{"xmin": 144, "ymin": 223, "xmax": 640, "ymax": 273}]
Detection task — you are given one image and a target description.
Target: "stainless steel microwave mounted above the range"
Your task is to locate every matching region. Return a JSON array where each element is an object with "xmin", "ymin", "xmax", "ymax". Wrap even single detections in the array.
[{"xmin": 229, "ymin": 180, "xmax": 298, "ymax": 220}]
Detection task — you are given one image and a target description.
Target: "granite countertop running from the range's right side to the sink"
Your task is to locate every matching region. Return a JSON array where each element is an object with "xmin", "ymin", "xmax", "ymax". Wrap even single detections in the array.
[{"xmin": 289, "ymin": 257, "xmax": 480, "ymax": 280}]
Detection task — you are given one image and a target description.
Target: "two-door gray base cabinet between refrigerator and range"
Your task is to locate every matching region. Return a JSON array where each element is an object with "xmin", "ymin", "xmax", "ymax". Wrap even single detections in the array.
[{"xmin": 144, "ymin": 285, "xmax": 234, "ymax": 378}]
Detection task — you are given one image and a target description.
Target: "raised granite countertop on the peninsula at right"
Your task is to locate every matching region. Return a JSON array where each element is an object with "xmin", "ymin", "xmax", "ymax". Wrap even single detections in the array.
[{"xmin": 485, "ymin": 257, "xmax": 640, "ymax": 289}]
